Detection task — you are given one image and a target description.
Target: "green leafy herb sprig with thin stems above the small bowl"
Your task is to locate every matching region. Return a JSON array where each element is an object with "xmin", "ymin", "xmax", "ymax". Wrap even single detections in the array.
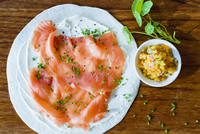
[{"xmin": 122, "ymin": 0, "xmax": 180, "ymax": 45}]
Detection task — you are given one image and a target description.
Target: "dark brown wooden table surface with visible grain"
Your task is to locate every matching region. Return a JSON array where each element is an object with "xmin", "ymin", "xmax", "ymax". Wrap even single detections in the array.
[{"xmin": 0, "ymin": 0, "xmax": 200, "ymax": 134}]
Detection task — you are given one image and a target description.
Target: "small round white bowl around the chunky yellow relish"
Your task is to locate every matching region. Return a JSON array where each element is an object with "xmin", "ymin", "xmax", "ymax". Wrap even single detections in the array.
[{"xmin": 134, "ymin": 39, "xmax": 182, "ymax": 87}]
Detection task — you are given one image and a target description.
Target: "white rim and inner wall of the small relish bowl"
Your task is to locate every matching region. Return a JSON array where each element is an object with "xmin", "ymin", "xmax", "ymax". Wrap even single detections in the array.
[{"xmin": 134, "ymin": 39, "xmax": 182, "ymax": 87}]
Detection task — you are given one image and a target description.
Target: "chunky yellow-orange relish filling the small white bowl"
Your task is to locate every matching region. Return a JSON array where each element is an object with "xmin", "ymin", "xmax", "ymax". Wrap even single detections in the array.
[{"xmin": 138, "ymin": 44, "xmax": 178, "ymax": 82}]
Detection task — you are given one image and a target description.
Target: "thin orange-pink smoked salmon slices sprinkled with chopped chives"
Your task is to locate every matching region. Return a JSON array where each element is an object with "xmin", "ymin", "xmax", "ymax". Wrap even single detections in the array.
[{"xmin": 29, "ymin": 20, "xmax": 125, "ymax": 130}]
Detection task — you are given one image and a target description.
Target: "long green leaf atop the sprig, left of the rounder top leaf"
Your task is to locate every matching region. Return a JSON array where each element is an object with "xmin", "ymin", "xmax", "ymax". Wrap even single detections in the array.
[{"xmin": 131, "ymin": 0, "xmax": 144, "ymax": 27}]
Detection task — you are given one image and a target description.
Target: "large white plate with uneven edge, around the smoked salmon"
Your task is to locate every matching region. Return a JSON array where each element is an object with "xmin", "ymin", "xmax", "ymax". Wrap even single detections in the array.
[{"xmin": 7, "ymin": 4, "xmax": 140, "ymax": 134}]
